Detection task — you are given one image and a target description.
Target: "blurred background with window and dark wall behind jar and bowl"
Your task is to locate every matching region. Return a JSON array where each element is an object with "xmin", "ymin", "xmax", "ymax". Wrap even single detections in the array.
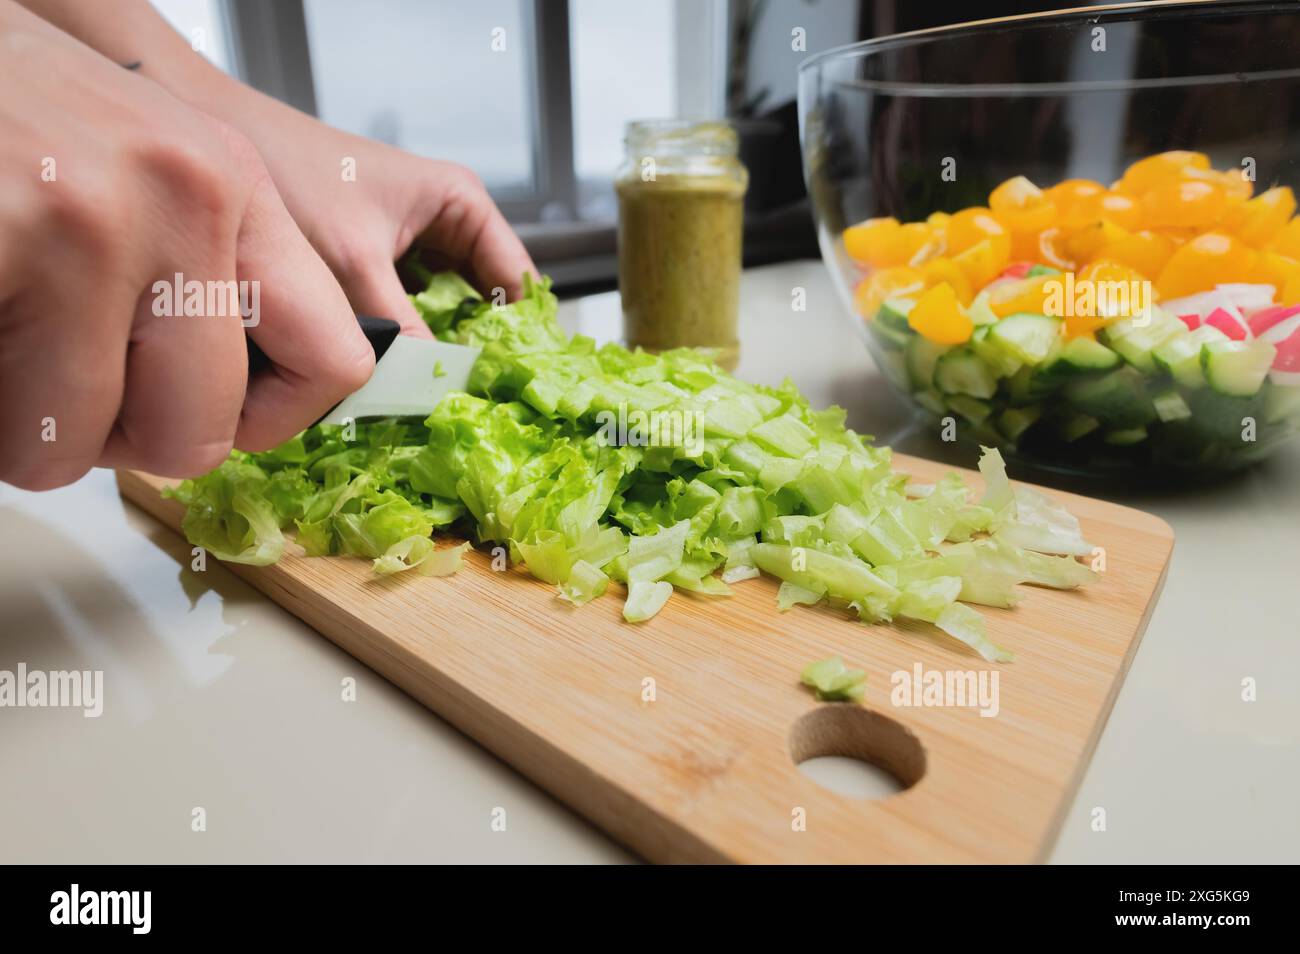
[{"xmin": 153, "ymin": 0, "xmax": 1170, "ymax": 294}]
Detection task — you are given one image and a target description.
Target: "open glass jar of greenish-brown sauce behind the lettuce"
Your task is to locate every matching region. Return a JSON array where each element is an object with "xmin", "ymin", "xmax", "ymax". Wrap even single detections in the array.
[{"xmin": 615, "ymin": 120, "xmax": 749, "ymax": 370}]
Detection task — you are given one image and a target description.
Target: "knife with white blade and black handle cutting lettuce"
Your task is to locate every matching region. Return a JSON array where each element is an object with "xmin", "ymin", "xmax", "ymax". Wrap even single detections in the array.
[{"xmin": 248, "ymin": 315, "xmax": 478, "ymax": 424}]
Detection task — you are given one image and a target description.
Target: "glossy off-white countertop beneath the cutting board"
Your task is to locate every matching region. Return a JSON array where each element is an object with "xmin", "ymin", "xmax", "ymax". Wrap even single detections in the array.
[{"xmin": 0, "ymin": 261, "xmax": 1300, "ymax": 863}]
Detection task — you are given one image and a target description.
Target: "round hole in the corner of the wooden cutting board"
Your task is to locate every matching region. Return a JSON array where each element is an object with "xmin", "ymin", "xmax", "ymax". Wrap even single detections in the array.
[{"xmin": 789, "ymin": 703, "xmax": 926, "ymax": 799}]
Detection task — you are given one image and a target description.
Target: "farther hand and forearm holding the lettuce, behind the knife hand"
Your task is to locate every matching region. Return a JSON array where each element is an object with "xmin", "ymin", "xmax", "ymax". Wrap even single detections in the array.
[{"xmin": 11, "ymin": 0, "xmax": 536, "ymax": 337}]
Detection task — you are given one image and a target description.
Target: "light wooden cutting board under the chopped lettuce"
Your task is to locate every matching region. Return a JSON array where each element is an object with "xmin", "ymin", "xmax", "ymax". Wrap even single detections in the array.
[{"xmin": 118, "ymin": 455, "xmax": 1174, "ymax": 862}]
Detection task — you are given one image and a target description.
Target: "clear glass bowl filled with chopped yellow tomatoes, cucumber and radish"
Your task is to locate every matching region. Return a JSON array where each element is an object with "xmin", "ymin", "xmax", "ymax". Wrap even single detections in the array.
[{"xmin": 798, "ymin": 3, "xmax": 1300, "ymax": 478}]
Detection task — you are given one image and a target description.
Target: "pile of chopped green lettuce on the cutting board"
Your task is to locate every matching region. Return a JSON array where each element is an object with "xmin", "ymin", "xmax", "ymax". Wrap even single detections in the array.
[{"xmin": 166, "ymin": 269, "xmax": 1096, "ymax": 662}]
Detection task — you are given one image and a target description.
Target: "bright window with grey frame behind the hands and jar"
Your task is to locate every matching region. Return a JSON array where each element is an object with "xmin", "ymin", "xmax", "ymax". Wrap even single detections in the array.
[{"xmin": 153, "ymin": 0, "xmax": 728, "ymax": 230}]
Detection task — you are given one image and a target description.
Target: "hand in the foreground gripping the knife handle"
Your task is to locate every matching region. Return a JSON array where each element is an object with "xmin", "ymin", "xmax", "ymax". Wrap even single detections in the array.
[{"xmin": 0, "ymin": 0, "xmax": 374, "ymax": 490}]
